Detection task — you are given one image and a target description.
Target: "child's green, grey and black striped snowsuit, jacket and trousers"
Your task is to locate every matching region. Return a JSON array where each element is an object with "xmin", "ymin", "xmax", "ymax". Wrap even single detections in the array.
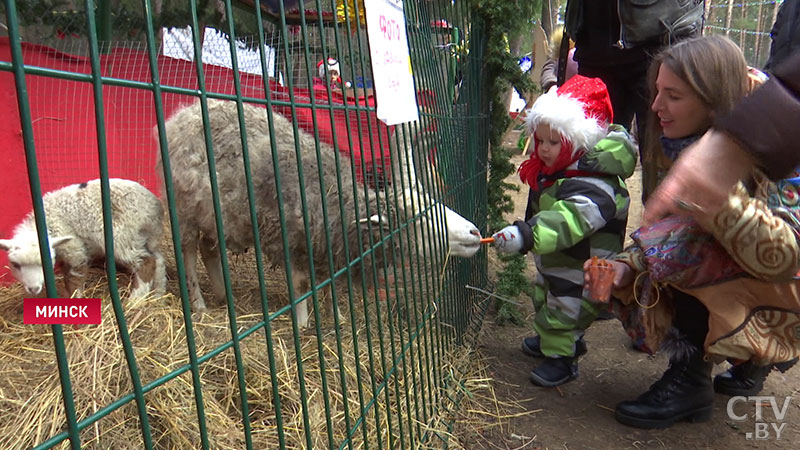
[{"xmin": 515, "ymin": 125, "xmax": 636, "ymax": 356}]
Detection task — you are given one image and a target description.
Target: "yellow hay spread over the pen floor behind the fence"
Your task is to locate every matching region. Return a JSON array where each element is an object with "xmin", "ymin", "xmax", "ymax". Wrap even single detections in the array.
[{"xmin": 0, "ymin": 256, "xmax": 496, "ymax": 449}]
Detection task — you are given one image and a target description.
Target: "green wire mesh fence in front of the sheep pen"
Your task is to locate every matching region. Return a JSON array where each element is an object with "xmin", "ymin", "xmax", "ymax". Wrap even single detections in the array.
[{"xmin": 0, "ymin": 0, "xmax": 488, "ymax": 449}]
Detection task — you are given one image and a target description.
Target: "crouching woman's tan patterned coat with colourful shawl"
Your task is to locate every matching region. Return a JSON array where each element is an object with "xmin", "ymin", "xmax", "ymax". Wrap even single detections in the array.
[{"xmin": 613, "ymin": 176, "xmax": 800, "ymax": 365}]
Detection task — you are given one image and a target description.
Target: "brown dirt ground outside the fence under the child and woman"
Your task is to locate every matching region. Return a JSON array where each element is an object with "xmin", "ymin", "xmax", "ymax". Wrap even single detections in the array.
[{"xmin": 466, "ymin": 136, "xmax": 800, "ymax": 450}]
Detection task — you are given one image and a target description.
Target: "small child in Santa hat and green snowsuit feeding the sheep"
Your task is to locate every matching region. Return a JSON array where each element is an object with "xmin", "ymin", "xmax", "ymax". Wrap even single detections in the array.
[{"xmin": 494, "ymin": 75, "xmax": 636, "ymax": 386}]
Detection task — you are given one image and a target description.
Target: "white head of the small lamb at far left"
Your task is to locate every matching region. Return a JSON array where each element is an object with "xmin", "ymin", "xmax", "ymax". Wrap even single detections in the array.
[{"xmin": 0, "ymin": 232, "xmax": 72, "ymax": 295}]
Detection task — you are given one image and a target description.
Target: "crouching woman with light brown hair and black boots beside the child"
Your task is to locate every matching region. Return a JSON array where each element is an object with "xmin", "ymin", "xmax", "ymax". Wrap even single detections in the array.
[{"xmin": 586, "ymin": 36, "xmax": 800, "ymax": 428}]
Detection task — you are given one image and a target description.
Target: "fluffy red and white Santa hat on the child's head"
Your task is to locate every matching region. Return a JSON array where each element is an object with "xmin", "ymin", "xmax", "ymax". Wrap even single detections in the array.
[{"xmin": 526, "ymin": 75, "xmax": 614, "ymax": 154}]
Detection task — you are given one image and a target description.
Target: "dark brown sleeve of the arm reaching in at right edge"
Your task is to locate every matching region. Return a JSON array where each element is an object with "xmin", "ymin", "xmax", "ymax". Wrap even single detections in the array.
[{"xmin": 714, "ymin": 50, "xmax": 800, "ymax": 180}]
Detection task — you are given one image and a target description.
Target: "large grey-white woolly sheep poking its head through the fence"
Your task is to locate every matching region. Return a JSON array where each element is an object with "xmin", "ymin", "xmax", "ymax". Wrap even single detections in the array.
[{"xmin": 159, "ymin": 100, "xmax": 480, "ymax": 326}]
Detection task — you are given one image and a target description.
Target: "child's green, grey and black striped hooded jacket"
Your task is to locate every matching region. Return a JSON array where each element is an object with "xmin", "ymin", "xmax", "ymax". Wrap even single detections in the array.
[{"xmin": 515, "ymin": 125, "xmax": 636, "ymax": 298}]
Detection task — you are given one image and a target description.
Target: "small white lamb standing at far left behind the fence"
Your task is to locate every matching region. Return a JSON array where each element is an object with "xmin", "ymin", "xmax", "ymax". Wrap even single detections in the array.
[{"xmin": 0, "ymin": 178, "xmax": 166, "ymax": 298}]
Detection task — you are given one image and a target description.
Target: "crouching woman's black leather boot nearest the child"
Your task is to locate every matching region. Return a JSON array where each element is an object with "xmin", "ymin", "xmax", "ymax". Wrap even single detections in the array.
[{"xmin": 614, "ymin": 350, "xmax": 714, "ymax": 428}]
